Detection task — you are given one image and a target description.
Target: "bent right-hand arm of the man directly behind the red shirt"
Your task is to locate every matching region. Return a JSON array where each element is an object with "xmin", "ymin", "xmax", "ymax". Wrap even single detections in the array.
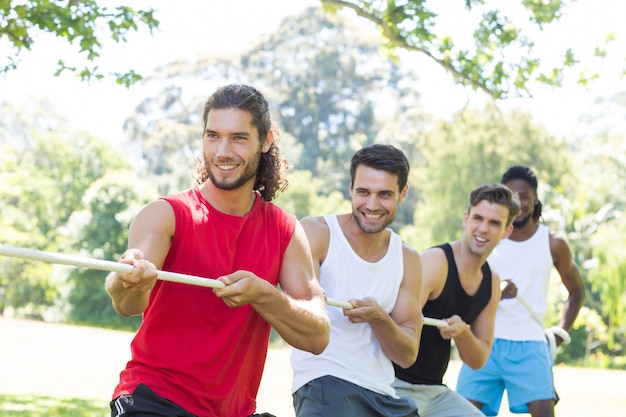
[{"xmin": 344, "ymin": 245, "xmax": 424, "ymax": 368}]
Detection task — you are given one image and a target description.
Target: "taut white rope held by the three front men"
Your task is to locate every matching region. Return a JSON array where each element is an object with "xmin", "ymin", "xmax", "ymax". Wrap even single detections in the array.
[{"xmin": 0, "ymin": 244, "xmax": 448, "ymax": 327}]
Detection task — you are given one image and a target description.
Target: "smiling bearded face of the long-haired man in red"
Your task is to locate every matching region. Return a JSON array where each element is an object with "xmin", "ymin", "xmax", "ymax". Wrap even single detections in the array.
[{"xmin": 203, "ymin": 108, "xmax": 271, "ymax": 190}]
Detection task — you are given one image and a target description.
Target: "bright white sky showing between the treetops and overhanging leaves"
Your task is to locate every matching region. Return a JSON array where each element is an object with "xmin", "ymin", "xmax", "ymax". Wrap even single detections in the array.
[{"xmin": 0, "ymin": 0, "xmax": 626, "ymax": 143}]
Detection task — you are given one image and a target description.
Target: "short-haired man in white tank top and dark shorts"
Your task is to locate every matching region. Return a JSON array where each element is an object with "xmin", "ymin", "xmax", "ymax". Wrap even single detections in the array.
[{"xmin": 291, "ymin": 145, "xmax": 423, "ymax": 417}]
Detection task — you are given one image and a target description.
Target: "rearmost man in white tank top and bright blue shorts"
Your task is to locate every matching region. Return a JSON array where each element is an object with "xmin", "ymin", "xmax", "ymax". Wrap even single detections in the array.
[{"xmin": 457, "ymin": 165, "xmax": 585, "ymax": 417}]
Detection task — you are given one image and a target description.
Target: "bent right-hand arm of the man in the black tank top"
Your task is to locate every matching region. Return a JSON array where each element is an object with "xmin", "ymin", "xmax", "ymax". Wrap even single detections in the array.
[{"xmin": 448, "ymin": 271, "xmax": 500, "ymax": 369}]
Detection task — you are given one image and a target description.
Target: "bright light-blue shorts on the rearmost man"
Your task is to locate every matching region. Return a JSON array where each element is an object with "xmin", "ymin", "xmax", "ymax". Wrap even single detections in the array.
[{"xmin": 456, "ymin": 339, "xmax": 558, "ymax": 416}]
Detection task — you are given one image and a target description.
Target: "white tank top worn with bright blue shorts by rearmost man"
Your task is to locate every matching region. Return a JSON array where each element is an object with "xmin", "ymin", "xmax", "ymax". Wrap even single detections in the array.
[{"xmin": 487, "ymin": 224, "xmax": 553, "ymax": 341}]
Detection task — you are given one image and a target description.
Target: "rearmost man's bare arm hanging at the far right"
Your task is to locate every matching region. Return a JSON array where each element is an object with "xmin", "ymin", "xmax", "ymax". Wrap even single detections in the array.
[{"xmin": 550, "ymin": 233, "xmax": 585, "ymax": 338}]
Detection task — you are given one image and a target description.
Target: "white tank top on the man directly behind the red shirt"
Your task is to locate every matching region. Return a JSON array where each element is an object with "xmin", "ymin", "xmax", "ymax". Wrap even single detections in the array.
[{"xmin": 291, "ymin": 215, "xmax": 404, "ymax": 397}]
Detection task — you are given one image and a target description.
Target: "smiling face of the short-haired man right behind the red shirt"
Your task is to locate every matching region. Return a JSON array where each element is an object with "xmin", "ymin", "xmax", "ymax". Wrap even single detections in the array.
[{"xmin": 350, "ymin": 165, "xmax": 408, "ymax": 233}]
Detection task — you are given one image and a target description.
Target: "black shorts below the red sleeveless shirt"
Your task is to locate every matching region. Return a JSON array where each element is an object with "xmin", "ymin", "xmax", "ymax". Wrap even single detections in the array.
[{"xmin": 110, "ymin": 384, "xmax": 275, "ymax": 417}]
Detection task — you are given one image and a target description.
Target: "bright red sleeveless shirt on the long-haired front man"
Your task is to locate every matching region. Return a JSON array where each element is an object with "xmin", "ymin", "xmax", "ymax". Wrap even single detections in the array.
[{"xmin": 113, "ymin": 187, "xmax": 295, "ymax": 417}]
